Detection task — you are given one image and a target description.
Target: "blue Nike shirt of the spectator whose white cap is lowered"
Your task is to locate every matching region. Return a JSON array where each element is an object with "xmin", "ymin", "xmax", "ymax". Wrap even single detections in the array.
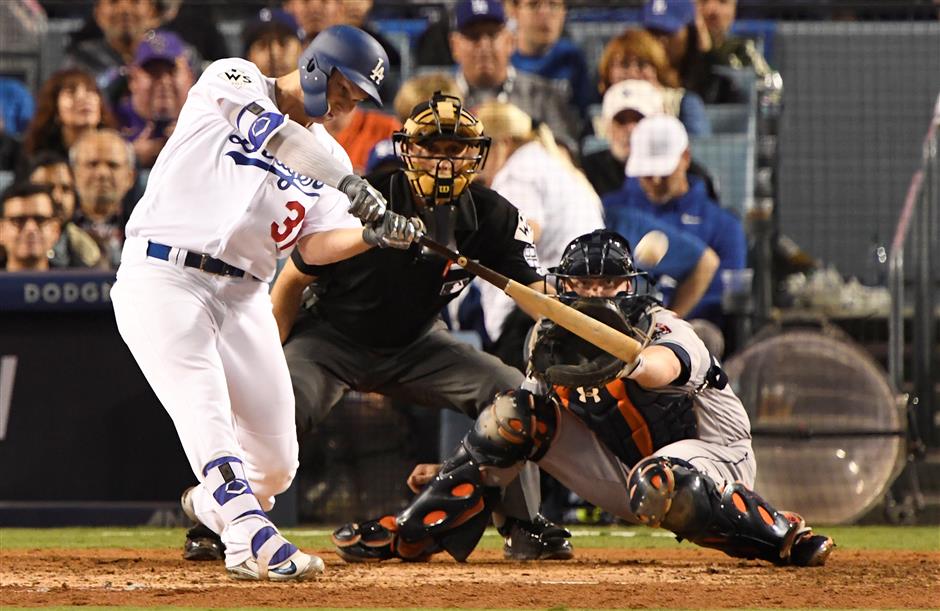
[{"xmin": 603, "ymin": 175, "xmax": 747, "ymax": 325}]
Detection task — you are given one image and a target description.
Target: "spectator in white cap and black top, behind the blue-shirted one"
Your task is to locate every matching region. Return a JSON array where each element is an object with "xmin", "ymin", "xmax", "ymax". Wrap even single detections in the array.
[{"xmin": 581, "ymin": 79, "xmax": 718, "ymax": 201}]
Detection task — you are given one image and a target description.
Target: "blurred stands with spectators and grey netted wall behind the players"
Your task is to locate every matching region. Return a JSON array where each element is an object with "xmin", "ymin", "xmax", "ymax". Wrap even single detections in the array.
[{"xmin": 0, "ymin": 0, "xmax": 940, "ymax": 524}]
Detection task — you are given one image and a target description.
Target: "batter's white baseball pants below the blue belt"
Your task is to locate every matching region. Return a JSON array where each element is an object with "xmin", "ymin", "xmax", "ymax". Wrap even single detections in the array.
[{"xmin": 111, "ymin": 238, "xmax": 298, "ymax": 532}]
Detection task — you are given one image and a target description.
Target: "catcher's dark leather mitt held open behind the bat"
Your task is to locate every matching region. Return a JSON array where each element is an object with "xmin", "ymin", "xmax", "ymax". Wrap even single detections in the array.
[{"xmin": 530, "ymin": 297, "xmax": 646, "ymax": 388}]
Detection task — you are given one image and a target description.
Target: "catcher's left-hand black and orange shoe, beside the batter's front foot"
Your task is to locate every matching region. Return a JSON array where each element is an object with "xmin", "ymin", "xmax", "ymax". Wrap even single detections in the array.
[{"xmin": 331, "ymin": 516, "xmax": 433, "ymax": 562}]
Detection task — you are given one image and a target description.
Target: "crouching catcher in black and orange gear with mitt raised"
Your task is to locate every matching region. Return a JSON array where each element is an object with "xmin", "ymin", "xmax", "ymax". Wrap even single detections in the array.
[{"xmin": 333, "ymin": 230, "xmax": 834, "ymax": 566}]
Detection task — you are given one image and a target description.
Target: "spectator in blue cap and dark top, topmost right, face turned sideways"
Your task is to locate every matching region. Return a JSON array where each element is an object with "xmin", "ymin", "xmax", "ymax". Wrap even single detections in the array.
[{"xmin": 642, "ymin": 0, "xmax": 745, "ymax": 104}]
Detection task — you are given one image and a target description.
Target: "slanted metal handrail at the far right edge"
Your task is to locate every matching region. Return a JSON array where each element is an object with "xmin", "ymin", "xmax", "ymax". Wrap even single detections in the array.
[{"xmin": 888, "ymin": 91, "xmax": 940, "ymax": 437}]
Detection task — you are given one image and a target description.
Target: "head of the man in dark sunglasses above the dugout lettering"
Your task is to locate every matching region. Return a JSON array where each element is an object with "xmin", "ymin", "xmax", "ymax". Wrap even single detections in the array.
[{"xmin": 0, "ymin": 183, "xmax": 60, "ymax": 272}]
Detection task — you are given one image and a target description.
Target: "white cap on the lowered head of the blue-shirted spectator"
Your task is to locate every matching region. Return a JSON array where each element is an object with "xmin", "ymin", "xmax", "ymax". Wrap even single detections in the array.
[{"xmin": 627, "ymin": 115, "xmax": 689, "ymax": 176}]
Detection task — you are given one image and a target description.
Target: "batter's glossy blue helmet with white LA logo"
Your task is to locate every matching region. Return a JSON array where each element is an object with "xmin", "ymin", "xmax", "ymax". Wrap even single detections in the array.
[{"xmin": 297, "ymin": 25, "xmax": 389, "ymax": 117}]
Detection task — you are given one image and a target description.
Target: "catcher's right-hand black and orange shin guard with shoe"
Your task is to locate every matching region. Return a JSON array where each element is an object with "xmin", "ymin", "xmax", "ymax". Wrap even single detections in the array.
[{"xmin": 628, "ymin": 456, "xmax": 833, "ymax": 566}]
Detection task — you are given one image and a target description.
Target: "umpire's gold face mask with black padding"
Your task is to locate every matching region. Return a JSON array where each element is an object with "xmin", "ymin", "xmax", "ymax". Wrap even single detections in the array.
[{"xmin": 392, "ymin": 91, "xmax": 490, "ymax": 206}]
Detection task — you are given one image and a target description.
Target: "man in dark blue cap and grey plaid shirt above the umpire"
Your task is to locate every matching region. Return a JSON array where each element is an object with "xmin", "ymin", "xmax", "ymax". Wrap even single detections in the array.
[{"xmin": 450, "ymin": 0, "xmax": 581, "ymax": 150}]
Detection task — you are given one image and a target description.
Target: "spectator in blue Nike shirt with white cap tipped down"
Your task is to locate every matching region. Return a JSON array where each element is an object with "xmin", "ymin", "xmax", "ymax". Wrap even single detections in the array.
[{"xmin": 603, "ymin": 115, "xmax": 747, "ymax": 328}]
